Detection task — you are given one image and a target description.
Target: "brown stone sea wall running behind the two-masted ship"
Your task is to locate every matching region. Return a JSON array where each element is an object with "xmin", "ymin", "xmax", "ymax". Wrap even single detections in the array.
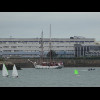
[{"xmin": 1, "ymin": 58, "xmax": 100, "ymax": 68}]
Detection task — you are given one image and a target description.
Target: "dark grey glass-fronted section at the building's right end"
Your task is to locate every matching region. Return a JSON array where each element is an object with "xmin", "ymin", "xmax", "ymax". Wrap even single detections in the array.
[{"xmin": 75, "ymin": 44, "xmax": 100, "ymax": 57}]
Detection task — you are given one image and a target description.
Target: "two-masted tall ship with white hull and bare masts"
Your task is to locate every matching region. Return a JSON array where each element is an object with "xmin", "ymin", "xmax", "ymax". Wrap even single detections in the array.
[{"xmin": 33, "ymin": 24, "xmax": 64, "ymax": 69}]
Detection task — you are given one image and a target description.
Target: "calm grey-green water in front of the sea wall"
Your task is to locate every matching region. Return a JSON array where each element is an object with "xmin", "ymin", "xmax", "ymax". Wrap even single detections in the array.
[{"xmin": 0, "ymin": 67, "xmax": 100, "ymax": 87}]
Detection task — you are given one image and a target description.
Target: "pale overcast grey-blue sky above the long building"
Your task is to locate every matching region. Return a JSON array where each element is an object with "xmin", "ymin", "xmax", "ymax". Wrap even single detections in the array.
[{"xmin": 0, "ymin": 12, "xmax": 100, "ymax": 41}]
